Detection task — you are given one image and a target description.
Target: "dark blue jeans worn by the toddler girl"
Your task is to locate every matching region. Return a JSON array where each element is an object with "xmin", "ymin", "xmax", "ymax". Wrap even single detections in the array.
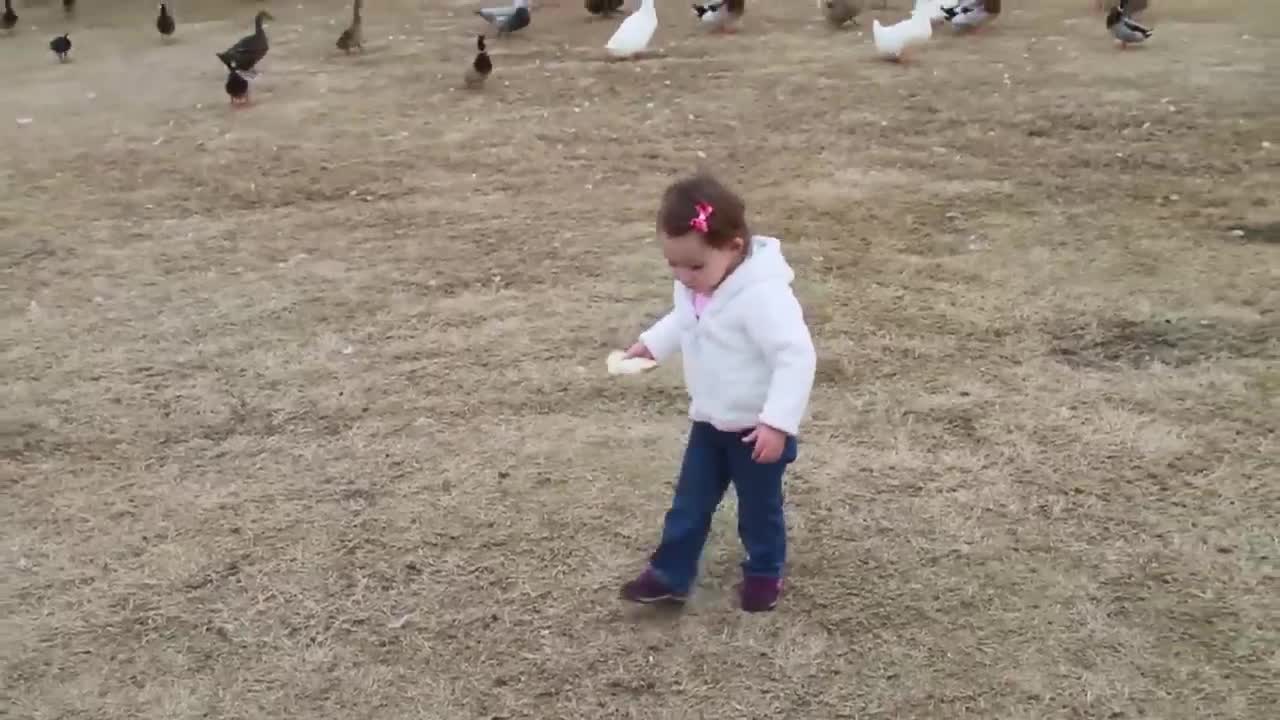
[{"xmin": 649, "ymin": 423, "xmax": 796, "ymax": 593}]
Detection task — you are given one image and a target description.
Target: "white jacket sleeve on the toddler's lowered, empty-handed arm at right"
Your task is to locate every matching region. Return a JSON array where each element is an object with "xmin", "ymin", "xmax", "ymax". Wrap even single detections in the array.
[{"xmin": 746, "ymin": 286, "xmax": 818, "ymax": 436}]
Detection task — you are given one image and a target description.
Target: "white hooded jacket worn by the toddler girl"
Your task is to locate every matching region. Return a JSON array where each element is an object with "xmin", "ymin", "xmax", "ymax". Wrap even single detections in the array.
[{"xmin": 640, "ymin": 236, "xmax": 817, "ymax": 436}]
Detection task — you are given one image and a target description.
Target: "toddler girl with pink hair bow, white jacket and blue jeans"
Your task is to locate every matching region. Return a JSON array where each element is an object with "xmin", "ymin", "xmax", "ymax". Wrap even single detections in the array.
[{"xmin": 622, "ymin": 170, "xmax": 815, "ymax": 612}]
